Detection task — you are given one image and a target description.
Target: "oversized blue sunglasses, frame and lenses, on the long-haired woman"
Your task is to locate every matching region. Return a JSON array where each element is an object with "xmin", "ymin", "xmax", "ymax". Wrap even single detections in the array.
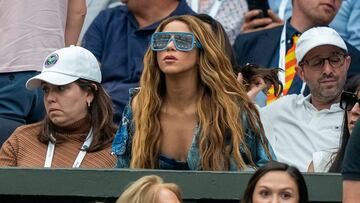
[{"xmin": 150, "ymin": 32, "xmax": 202, "ymax": 51}]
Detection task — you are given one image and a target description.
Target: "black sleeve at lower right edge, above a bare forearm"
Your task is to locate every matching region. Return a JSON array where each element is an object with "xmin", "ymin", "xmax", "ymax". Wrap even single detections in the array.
[{"xmin": 342, "ymin": 119, "xmax": 360, "ymax": 180}]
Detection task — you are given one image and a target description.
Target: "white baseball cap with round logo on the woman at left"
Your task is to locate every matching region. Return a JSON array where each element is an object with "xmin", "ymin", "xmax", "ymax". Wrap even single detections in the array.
[{"xmin": 26, "ymin": 45, "xmax": 101, "ymax": 90}]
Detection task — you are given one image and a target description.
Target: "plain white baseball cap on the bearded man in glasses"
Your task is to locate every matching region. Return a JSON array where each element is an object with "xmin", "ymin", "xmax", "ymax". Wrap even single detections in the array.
[{"xmin": 295, "ymin": 27, "xmax": 347, "ymax": 64}]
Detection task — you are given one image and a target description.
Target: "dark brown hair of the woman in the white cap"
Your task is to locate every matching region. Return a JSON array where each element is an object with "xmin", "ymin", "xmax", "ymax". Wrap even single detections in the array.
[{"xmin": 38, "ymin": 79, "xmax": 117, "ymax": 152}]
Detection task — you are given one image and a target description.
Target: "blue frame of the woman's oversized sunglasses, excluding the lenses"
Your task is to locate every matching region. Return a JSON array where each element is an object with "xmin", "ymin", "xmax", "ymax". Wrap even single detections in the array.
[{"xmin": 150, "ymin": 32, "xmax": 202, "ymax": 52}]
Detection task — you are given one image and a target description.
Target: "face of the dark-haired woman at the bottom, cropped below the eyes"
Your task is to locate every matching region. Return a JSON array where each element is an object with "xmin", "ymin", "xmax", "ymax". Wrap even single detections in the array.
[{"xmin": 252, "ymin": 171, "xmax": 300, "ymax": 203}]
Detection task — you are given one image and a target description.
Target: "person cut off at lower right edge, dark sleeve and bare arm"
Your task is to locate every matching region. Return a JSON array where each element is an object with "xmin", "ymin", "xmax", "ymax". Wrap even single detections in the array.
[{"xmin": 342, "ymin": 118, "xmax": 360, "ymax": 203}]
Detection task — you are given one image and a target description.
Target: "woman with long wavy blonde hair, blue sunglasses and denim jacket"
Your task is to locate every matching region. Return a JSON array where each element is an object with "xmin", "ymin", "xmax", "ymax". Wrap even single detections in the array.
[{"xmin": 113, "ymin": 15, "xmax": 273, "ymax": 170}]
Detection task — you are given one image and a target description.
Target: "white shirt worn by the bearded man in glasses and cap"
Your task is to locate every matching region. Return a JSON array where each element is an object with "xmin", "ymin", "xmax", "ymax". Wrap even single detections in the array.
[{"xmin": 260, "ymin": 94, "xmax": 344, "ymax": 172}]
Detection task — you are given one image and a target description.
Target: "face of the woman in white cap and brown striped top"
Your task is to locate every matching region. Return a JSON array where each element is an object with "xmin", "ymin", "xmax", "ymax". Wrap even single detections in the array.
[{"xmin": 41, "ymin": 82, "xmax": 93, "ymax": 126}]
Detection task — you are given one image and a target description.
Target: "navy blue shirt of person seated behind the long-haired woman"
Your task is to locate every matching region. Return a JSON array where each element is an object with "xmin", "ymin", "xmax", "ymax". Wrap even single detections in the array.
[{"xmin": 82, "ymin": 0, "xmax": 194, "ymax": 123}]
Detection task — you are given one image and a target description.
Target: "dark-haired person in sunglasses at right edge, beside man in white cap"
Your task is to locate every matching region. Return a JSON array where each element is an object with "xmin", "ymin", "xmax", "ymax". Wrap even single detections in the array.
[{"xmin": 308, "ymin": 75, "xmax": 360, "ymax": 173}]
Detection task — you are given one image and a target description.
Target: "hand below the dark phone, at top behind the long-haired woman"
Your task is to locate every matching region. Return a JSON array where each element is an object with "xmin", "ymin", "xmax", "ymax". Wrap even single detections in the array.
[{"xmin": 241, "ymin": 9, "xmax": 284, "ymax": 33}]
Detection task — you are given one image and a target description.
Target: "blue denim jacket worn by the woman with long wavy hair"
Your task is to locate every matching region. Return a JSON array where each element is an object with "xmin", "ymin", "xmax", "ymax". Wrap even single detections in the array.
[{"xmin": 112, "ymin": 88, "xmax": 275, "ymax": 171}]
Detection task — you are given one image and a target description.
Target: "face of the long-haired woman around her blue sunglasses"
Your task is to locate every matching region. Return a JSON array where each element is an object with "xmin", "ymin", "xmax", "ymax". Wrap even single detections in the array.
[{"xmin": 156, "ymin": 21, "xmax": 198, "ymax": 75}]
